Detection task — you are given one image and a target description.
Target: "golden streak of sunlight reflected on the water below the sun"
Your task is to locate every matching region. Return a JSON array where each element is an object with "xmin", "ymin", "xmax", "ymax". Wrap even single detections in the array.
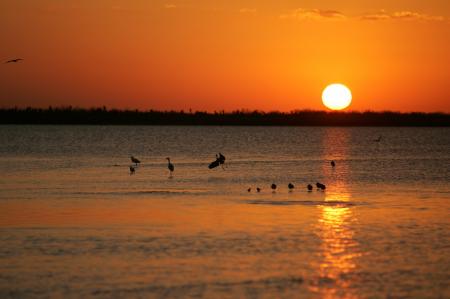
[{"xmin": 313, "ymin": 128, "xmax": 361, "ymax": 299}]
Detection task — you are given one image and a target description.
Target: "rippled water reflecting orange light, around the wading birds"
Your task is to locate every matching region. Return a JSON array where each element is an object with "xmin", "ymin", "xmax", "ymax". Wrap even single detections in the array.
[{"xmin": 0, "ymin": 126, "xmax": 450, "ymax": 298}]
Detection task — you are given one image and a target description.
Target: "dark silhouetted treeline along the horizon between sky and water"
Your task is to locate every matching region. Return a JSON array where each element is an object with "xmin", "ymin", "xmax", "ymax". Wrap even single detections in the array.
[{"xmin": 0, "ymin": 107, "xmax": 450, "ymax": 126}]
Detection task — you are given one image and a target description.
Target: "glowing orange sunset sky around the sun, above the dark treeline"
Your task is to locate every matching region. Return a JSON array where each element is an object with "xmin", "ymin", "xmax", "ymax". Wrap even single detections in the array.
[{"xmin": 0, "ymin": 0, "xmax": 450, "ymax": 112}]
